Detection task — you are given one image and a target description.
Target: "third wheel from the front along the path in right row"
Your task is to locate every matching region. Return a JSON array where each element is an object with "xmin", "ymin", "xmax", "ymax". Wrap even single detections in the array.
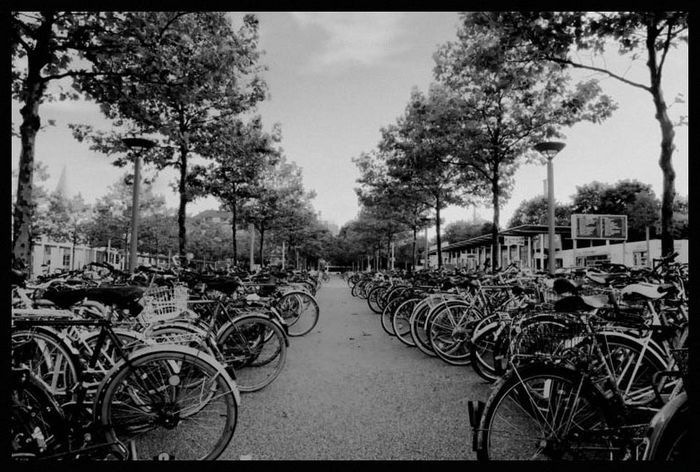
[{"xmin": 426, "ymin": 302, "xmax": 481, "ymax": 365}]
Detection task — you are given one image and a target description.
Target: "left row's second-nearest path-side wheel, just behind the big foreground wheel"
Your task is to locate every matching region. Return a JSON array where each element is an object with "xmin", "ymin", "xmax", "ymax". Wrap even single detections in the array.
[{"xmin": 216, "ymin": 315, "xmax": 288, "ymax": 392}]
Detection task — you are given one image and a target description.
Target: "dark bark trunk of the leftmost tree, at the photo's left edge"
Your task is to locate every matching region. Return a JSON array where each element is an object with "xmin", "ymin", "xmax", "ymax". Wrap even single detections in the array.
[{"xmin": 12, "ymin": 12, "xmax": 54, "ymax": 267}]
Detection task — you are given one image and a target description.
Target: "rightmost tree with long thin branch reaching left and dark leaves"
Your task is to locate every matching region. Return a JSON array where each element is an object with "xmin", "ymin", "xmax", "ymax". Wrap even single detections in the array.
[{"xmin": 478, "ymin": 10, "xmax": 688, "ymax": 255}]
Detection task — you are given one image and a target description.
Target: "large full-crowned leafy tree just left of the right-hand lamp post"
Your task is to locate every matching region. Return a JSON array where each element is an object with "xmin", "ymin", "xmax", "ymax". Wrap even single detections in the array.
[{"xmin": 435, "ymin": 13, "xmax": 615, "ymax": 270}]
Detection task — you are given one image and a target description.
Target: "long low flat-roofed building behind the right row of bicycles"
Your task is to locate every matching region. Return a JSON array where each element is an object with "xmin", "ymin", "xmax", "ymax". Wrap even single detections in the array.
[{"xmin": 428, "ymin": 225, "xmax": 688, "ymax": 270}]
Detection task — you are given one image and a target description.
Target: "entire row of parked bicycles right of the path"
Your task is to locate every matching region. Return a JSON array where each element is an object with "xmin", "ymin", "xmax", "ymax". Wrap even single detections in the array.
[{"xmin": 346, "ymin": 253, "xmax": 690, "ymax": 460}]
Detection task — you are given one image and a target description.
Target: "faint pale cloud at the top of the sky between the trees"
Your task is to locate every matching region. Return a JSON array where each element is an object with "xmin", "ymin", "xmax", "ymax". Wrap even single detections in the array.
[{"xmin": 292, "ymin": 12, "xmax": 407, "ymax": 69}]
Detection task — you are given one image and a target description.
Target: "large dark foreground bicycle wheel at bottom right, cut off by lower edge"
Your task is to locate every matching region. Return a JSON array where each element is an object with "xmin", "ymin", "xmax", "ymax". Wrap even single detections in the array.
[{"xmin": 476, "ymin": 363, "xmax": 616, "ymax": 460}]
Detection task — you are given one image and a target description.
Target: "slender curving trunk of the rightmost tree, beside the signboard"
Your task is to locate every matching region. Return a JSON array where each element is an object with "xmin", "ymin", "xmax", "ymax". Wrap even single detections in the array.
[{"xmin": 646, "ymin": 20, "xmax": 676, "ymax": 256}]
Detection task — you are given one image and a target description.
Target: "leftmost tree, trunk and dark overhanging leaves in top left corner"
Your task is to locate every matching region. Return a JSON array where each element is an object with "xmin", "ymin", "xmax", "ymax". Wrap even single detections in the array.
[{"xmin": 10, "ymin": 11, "xmax": 138, "ymax": 263}]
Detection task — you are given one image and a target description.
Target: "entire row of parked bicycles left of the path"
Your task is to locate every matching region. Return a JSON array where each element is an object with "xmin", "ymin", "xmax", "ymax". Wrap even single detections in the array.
[{"xmin": 9, "ymin": 263, "xmax": 321, "ymax": 460}]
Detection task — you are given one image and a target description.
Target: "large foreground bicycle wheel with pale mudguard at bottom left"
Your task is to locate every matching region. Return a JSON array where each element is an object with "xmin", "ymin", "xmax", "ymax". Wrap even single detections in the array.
[{"xmin": 94, "ymin": 345, "xmax": 240, "ymax": 460}]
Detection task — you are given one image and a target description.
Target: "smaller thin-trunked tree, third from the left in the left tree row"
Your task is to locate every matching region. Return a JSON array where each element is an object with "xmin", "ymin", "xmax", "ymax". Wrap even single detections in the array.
[{"xmin": 200, "ymin": 117, "xmax": 281, "ymax": 259}]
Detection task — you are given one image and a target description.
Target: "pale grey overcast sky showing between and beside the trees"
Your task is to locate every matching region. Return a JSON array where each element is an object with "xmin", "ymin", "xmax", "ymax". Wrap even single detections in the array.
[{"xmin": 12, "ymin": 12, "xmax": 688, "ymax": 236}]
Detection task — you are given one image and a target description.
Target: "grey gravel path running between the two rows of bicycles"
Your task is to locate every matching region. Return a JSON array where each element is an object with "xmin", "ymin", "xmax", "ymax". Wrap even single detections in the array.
[{"xmin": 221, "ymin": 276, "xmax": 489, "ymax": 460}]
